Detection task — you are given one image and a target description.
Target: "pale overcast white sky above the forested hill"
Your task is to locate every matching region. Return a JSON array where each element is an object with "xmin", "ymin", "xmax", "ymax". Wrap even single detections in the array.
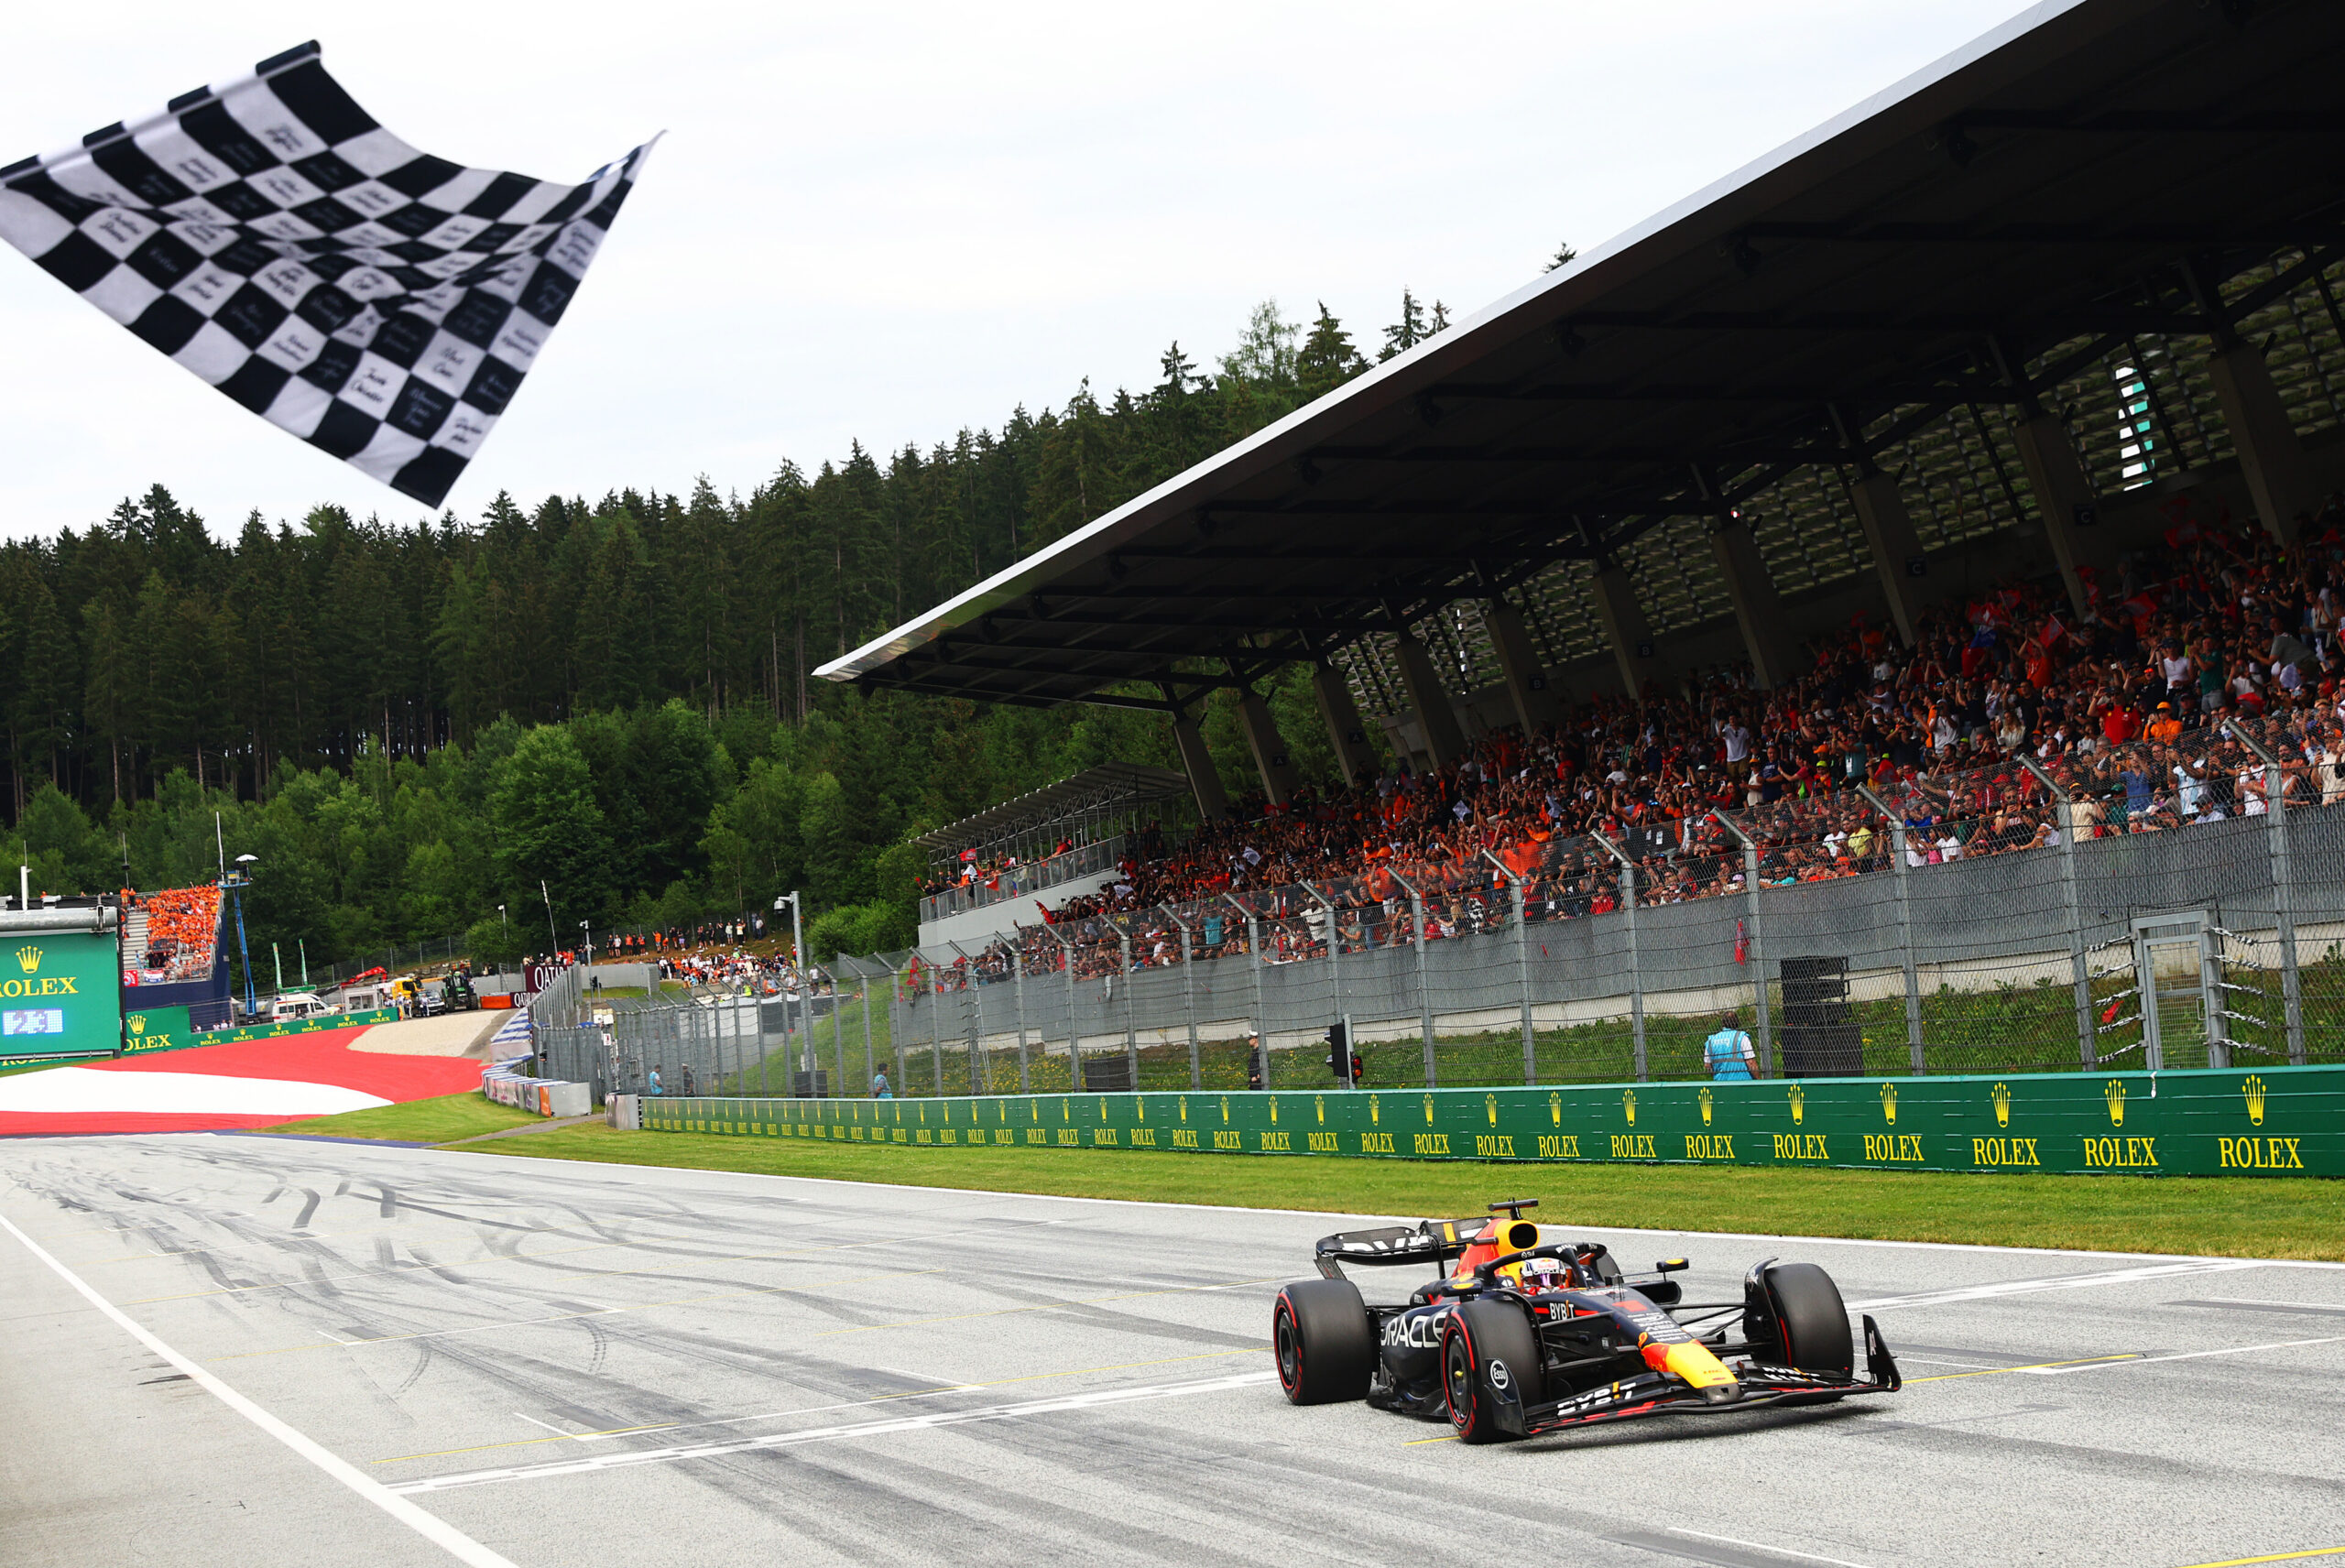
[{"xmin": 0, "ymin": 0, "xmax": 2022, "ymax": 534}]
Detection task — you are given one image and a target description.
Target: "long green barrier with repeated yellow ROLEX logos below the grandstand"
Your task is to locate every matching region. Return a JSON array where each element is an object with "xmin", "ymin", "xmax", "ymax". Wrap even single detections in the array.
[{"xmin": 642, "ymin": 1066, "xmax": 2345, "ymax": 1177}]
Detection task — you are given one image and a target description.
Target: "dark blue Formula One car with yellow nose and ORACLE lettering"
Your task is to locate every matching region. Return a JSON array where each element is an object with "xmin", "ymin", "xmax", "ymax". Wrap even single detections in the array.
[{"xmin": 1271, "ymin": 1198, "xmax": 1902, "ymax": 1443}]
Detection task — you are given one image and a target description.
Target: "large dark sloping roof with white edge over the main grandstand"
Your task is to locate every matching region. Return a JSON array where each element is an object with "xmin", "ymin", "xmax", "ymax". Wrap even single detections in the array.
[{"xmin": 818, "ymin": 0, "xmax": 2345, "ymax": 705}]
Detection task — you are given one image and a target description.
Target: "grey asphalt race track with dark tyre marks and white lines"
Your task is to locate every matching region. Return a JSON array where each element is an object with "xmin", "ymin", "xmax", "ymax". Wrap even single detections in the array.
[{"xmin": 0, "ymin": 1135, "xmax": 2345, "ymax": 1568}]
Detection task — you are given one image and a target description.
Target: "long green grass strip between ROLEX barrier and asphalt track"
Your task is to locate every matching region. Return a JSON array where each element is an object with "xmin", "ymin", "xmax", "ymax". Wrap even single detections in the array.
[{"xmin": 457, "ymin": 1111, "xmax": 2345, "ymax": 1261}]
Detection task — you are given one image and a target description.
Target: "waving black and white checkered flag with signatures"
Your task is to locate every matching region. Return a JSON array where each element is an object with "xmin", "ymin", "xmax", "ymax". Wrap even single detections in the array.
[{"xmin": 0, "ymin": 42, "xmax": 649, "ymax": 506}]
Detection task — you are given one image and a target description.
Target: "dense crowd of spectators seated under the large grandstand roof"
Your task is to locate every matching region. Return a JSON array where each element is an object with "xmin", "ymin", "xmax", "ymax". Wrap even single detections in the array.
[{"xmin": 910, "ymin": 499, "xmax": 2345, "ymax": 985}]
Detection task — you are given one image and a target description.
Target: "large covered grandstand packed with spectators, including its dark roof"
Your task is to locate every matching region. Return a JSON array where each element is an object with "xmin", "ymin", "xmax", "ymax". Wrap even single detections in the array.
[{"xmin": 821, "ymin": 0, "xmax": 2345, "ymax": 1083}]
